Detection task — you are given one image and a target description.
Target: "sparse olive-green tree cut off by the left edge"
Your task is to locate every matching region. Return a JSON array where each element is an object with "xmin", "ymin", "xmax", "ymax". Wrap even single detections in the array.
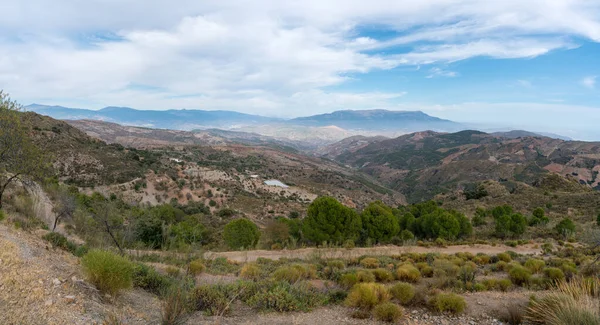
[{"xmin": 0, "ymin": 91, "xmax": 47, "ymax": 208}]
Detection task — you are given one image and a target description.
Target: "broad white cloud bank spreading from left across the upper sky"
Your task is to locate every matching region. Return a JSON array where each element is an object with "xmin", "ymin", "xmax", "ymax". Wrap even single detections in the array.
[{"xmin": 0, "ymin": 0, "xmax": 600, "ymax": 115}]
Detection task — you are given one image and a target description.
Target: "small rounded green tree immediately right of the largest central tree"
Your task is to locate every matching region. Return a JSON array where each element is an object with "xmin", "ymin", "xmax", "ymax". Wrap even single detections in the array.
[{"xmin": 361, "ymin": 201, "xmax": 400, "ymax": 243}]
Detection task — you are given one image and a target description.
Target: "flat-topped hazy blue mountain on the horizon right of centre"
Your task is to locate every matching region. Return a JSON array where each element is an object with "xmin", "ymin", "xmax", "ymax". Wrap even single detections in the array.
[{"xmin": 288, "ymin": 109, "xmax": 465, "ymax": 132}]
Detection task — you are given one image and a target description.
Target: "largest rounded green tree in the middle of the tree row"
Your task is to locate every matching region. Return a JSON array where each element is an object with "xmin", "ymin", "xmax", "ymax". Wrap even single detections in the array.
[{"xmin": 302, "ymin": 196, "xmax": 362, "ymax": 243}]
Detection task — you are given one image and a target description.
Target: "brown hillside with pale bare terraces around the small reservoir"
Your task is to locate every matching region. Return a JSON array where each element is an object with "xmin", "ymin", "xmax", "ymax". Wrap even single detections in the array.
[{"xmin": 27, "ymin": 113, "xmax": 406, "ymax": 218}]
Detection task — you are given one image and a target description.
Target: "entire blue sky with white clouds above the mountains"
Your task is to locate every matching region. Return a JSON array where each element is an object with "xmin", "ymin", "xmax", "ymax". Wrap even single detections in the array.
[{"xmin": 0, "ymin": 0, "xmax": 600, "ymax": 140}]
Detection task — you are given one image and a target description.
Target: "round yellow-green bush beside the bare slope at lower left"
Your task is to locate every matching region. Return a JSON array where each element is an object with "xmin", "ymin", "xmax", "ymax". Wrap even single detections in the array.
[{"xmin": 81, "ymin": 250, "xmax": 133, "ymax": 295}]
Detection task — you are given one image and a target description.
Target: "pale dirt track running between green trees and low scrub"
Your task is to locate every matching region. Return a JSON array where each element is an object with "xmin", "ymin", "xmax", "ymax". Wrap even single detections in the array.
[{"xmin": 204, "ymin": 244, "xmax": 542, "ymax": 262}]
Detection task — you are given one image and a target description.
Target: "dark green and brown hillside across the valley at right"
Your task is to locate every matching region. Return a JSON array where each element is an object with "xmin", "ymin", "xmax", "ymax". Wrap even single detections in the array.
[{"xmin": 321, "ymin": 131, "xmax": 600, "ymax": 202}]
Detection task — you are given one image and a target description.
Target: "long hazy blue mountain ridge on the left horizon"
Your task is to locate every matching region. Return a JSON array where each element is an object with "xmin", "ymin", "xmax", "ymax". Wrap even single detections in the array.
[{"xmin": 25, "ymin": 104, "xmax": 280, "ymax": 130}]
